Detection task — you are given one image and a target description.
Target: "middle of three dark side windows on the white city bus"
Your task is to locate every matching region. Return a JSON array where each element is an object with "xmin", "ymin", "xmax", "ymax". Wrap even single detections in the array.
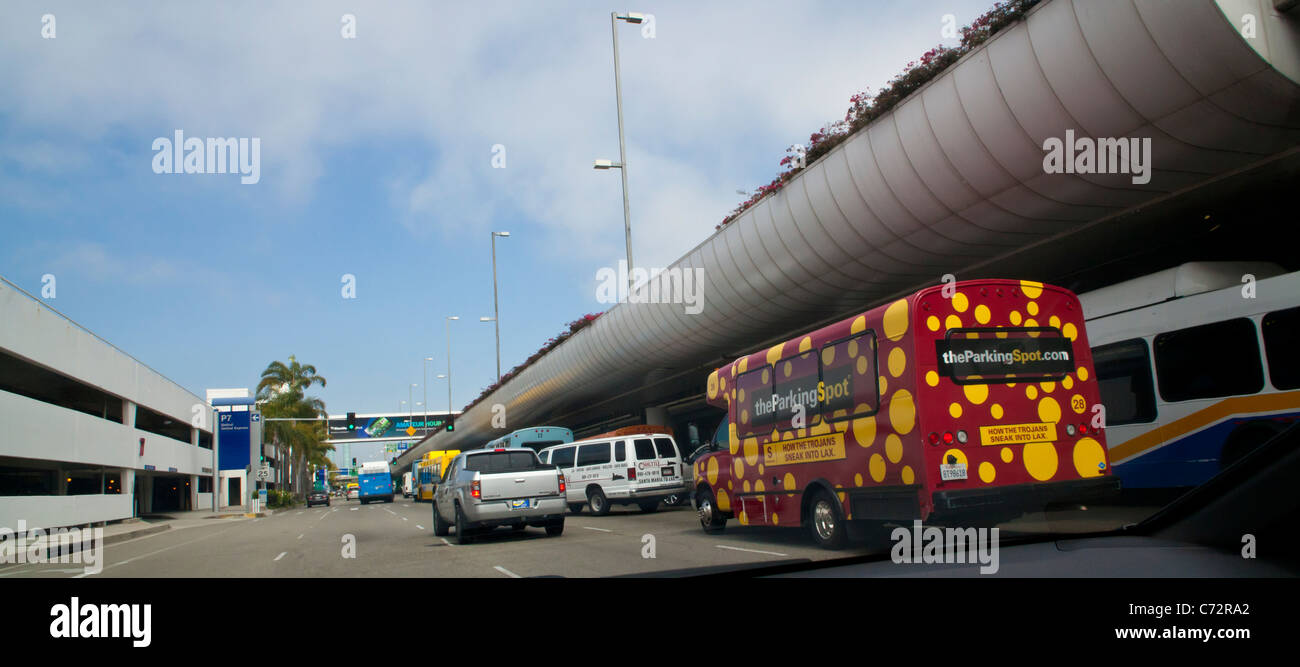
[{"xmin": 1153, "ymin": 317, "xmax": 1264, "ymax": 402}]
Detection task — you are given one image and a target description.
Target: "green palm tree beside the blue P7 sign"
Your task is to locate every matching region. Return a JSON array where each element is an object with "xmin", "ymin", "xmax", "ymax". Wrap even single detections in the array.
[{"xmin": 257, "ymin": 355, "xmax": 334, "ymax": 495}]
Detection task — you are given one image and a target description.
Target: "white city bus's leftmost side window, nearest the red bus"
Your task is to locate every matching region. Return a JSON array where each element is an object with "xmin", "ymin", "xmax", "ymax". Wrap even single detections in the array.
[{"xmin": 1092, "ymin": 338, "xmax": 1156, "ymax": 426}]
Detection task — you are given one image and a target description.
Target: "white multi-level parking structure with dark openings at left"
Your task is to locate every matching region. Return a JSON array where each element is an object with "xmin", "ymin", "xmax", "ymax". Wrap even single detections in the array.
[{"xmin": 0, "ymin": 278, "xmax": 217, "ymax": 529}]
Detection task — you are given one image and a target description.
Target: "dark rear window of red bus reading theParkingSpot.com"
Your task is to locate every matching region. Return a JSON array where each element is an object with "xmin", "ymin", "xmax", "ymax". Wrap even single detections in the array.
[{"xmin": 935, "ymin": 326, "xmax": 1075, "ymax": 385}]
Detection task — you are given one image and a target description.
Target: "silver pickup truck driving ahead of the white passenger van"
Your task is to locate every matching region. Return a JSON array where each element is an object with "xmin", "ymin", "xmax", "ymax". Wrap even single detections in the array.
[{"xmin": 433, "ymin": 449, "xmax": 567, "ymax": 545}]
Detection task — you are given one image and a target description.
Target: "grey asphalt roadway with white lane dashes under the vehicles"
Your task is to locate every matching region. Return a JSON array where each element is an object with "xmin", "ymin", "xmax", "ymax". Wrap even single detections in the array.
[{"xmin": 0, "ymin": 498, "xmax": 1154, "ymax": 577}]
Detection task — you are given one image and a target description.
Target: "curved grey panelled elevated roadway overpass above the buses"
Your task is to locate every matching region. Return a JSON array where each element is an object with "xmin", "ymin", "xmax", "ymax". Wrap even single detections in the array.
[{"xmin": 398, "ymin": 0, "xmax": 1300, "ymax": 468}]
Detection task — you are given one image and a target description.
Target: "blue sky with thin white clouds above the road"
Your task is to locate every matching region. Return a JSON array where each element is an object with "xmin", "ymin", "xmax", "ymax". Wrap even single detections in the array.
[{"xmin": 0, "ymin": 0, "xmax": 992, "ymax": 415}]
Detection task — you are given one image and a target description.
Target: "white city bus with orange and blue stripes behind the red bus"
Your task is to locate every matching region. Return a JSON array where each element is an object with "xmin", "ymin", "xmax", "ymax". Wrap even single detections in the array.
[{"xmin": 1079, "ymin": 261, "xmax": 1300, "ymax": 489}]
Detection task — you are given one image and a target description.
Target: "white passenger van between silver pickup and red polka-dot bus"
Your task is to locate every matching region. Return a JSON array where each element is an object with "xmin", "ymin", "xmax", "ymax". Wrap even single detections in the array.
[{"xmin": 540, "ymin": 433, "xmax": 686, "ymax": 515}]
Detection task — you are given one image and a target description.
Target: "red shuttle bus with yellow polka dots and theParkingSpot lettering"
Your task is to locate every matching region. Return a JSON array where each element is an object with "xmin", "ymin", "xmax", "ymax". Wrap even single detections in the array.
[{"xmin": 694, "ymin": 280, "xmax": 1119, "ymax": 549}]
